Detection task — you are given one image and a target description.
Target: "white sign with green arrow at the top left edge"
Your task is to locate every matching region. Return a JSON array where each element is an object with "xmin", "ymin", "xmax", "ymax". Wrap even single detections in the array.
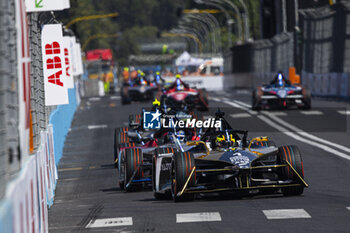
[{"xmin": 25, "ymin": 0, "xmax": 70, "ymax": 12}]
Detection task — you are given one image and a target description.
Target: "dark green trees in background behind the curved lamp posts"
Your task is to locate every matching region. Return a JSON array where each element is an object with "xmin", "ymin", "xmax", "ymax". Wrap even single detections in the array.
[{"xmin": 56, "ymin": 0, "xmax": 260, "ymax": 61}]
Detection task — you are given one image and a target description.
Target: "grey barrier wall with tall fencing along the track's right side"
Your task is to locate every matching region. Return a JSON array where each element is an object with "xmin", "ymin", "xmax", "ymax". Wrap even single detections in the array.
[{"xmin": 224, "ymin": 0, "xmax": 350, "ymax": 97}]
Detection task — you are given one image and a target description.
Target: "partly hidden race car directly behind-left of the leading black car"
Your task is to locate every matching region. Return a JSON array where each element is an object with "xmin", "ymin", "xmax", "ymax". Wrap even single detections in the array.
[{"xmin": 114, "ymin": 108, "xmax": 202, "ymax": 191}]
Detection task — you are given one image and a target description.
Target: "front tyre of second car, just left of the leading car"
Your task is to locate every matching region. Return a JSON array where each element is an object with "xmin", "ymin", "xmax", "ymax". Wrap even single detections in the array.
[{"xmin": 124, "ymin": 148, "xmax": 143, "ymax": 192}]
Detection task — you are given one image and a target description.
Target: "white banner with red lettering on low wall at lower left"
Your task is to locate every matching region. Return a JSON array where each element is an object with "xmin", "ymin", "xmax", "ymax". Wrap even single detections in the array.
[{"xmin": 6, "ymin": 125, "xmax": 58, "ymax": 233}]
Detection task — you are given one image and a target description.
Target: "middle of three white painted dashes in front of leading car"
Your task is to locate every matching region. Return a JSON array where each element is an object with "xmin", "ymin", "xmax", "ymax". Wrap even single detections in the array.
[{"xmin": 176, "ymin": 212, "xmax": 222, "ymax": 223}]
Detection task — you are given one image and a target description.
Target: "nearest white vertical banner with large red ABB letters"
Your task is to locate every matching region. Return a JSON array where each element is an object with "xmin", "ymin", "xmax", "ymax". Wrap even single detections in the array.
[{"xmin": 41, "ymin": 24, "xmax": 69, "ymax": 106}]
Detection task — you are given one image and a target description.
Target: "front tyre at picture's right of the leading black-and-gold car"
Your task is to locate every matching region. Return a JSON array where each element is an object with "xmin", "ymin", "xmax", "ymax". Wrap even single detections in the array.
[{"xmin": 278, "ymin": 146, "xmax": 304, "ymax": 196}]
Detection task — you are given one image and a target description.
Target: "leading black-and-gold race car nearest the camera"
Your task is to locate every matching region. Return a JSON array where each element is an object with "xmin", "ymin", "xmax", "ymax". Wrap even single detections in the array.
[{"xmin": 152, "ymin": 110, "xmax": 308, "ymax": 202}]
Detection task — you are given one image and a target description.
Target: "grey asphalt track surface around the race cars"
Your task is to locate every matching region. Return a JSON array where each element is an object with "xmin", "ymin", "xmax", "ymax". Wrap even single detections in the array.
[{"xmin": 49, "ymin": 91, "xmax": 350, "ymax": 233}]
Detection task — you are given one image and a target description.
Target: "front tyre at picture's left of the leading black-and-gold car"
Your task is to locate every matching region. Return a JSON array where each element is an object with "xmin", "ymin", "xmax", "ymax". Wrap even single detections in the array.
[{"xmin": 170, "ymin": 152, "xmax": 196, "ymax": 202}]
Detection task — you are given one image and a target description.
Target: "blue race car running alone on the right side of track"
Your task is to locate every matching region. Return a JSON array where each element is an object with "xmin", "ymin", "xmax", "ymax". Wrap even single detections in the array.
[{"xmin": 252, "ymin": 73, "xmax": 311, "ymax": 110}]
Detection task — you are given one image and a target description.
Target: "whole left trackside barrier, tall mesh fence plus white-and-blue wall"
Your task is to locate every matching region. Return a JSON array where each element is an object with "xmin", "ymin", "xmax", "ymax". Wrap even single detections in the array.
[{"xmin": 0, "ymin": 0, "xmax": 84, "ymax": 230}]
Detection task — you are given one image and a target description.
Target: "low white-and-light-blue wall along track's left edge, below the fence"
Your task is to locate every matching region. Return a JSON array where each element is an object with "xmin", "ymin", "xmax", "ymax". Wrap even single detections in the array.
[{"xmin": 0, "ymin": 86, "xmax": 80, "ymax": 233}]
